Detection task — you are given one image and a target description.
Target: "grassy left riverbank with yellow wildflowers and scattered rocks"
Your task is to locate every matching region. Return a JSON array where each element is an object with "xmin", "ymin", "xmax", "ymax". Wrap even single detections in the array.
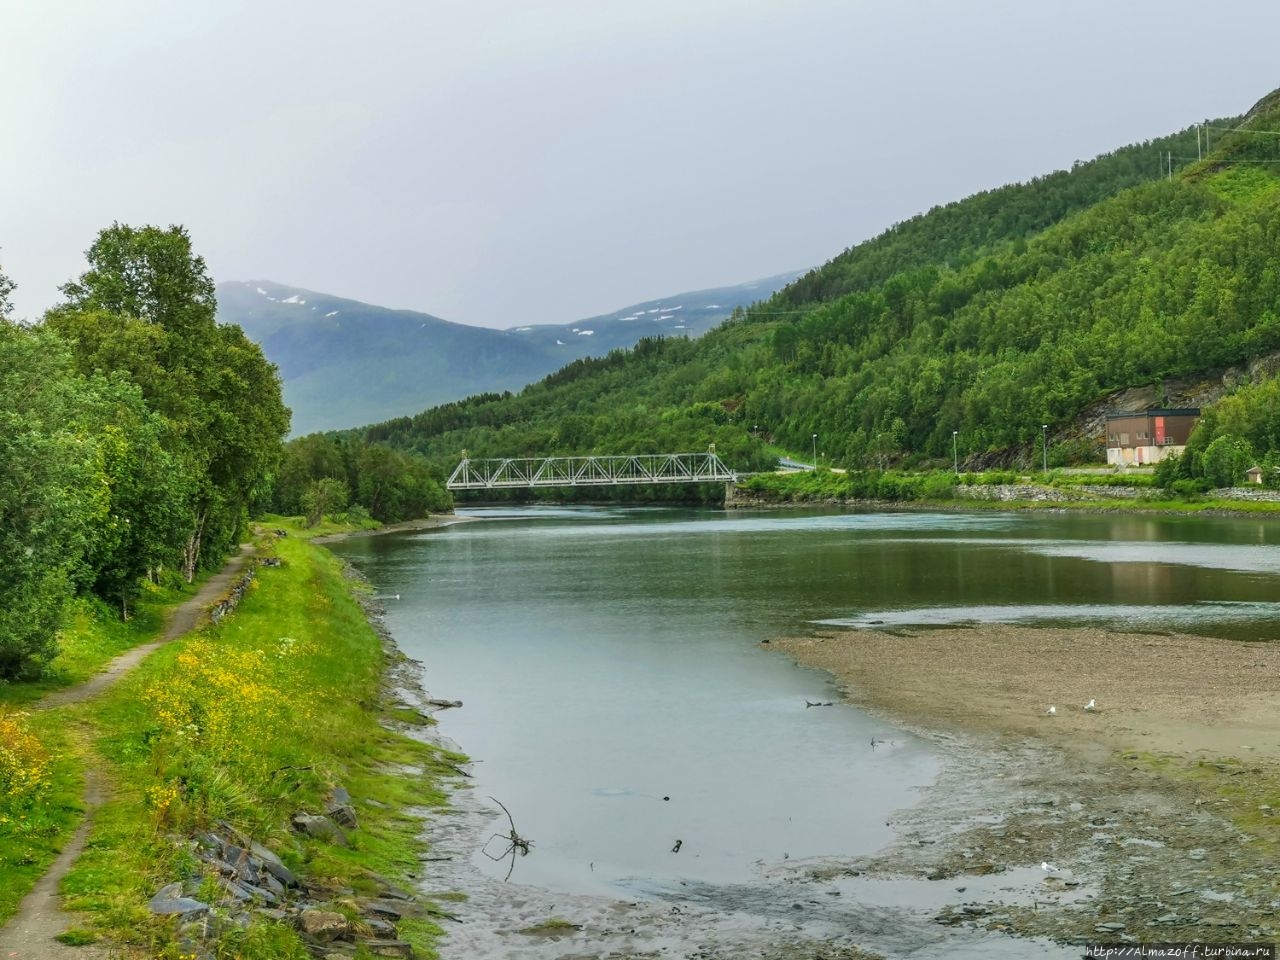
[{"xmin": 0, "ymin": 536, "xmax": 460, "ymax": 960}]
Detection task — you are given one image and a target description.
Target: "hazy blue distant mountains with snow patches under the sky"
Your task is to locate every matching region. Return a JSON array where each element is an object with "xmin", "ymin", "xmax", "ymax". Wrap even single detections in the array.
[{"xmin": 218, "ymin": 273, "xmax": 800, "ymax": 435}]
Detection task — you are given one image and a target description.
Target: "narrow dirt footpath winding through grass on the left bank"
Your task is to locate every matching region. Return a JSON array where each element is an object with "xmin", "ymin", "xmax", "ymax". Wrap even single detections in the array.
[{"xmin": 0, "ymin": 544, "xmax": 253, "ymax": 960}]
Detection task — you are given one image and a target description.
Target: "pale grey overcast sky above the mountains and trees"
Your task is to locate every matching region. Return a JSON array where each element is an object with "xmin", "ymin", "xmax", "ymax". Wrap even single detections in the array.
[{"xmin": 0, "ymin": 0, "xmax": 1280, "ymax": 326}]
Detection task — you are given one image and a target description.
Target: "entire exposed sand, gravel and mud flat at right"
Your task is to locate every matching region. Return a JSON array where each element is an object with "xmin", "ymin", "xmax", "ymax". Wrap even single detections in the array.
[{"xmin": 767, "ymin": 625, "xmax": 1280, "ymax": 943}]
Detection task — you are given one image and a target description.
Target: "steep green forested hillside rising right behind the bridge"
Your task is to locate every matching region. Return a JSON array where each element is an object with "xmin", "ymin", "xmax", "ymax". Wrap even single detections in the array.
[{"xmin": 355, "ymin": 97, "xmax": 1280, "ymax": 478}]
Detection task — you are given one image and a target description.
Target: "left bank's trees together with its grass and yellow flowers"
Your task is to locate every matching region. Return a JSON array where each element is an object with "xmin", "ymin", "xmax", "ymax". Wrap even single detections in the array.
[{"xmin": 0, "ymin": 224, "xmax": 449, "ymax": 956}]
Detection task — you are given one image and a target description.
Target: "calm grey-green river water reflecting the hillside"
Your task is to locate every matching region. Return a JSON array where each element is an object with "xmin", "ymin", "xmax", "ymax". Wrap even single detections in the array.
[{"xmin": 334, "ymin": 508, "xmax": 1280, "ymax": 896}]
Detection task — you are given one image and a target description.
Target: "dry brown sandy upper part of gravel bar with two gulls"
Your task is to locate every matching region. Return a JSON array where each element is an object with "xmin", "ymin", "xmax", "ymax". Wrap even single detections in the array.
[{"xmin": 776, "ymin": 625, "xmax": 1280, "ymax": 759}]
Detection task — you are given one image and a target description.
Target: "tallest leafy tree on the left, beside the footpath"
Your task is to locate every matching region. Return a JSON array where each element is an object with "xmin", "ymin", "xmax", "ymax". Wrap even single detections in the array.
[{"xmin": 47, "ymin": 223, "xmax": 289, "ymax": 581}]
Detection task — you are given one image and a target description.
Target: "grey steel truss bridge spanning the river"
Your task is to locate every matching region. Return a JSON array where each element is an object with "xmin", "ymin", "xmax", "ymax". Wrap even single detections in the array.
[{"xmin": 448, "ymin": 451, "xmax": 739, "ymax": 490}]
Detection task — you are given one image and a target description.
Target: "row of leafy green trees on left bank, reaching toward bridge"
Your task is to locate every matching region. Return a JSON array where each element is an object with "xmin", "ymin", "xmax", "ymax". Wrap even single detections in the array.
[{"xmin": 0, "ymin": 224, "xmax": 449, "ymax": 682}]
